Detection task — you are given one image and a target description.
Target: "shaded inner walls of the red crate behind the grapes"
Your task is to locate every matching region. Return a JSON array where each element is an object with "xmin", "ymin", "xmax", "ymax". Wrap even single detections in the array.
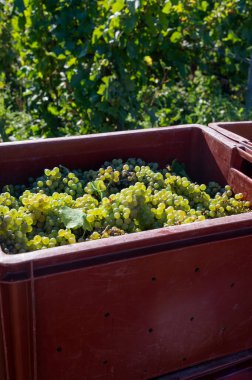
[{"xmin": 0, "ymin": 126, "xmax": 238, "ymax": 187}]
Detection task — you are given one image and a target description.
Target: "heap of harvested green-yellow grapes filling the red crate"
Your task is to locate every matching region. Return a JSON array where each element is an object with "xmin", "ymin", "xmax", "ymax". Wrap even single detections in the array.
[{"xmin": 0, "ymin": 158, "xmax": 251, "ymax": 254}]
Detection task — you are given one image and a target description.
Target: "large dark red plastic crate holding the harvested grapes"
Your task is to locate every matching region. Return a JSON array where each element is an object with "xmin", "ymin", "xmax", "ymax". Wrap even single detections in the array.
[{"xmin": 0, "ymin": 125, "xmax": 252, "ymax": 380}]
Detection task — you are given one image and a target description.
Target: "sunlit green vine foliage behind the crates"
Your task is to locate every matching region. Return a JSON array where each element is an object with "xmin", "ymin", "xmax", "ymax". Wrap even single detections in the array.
[{"xmin": 0, "ymin": 0, "xmax": 252, "ymax": 141}]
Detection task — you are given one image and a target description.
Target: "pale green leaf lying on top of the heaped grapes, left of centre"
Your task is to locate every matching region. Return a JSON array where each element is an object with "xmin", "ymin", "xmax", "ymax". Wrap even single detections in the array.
[{"xmin": 59, "ymin": 206, "xmax": 92, "ymax": 231}]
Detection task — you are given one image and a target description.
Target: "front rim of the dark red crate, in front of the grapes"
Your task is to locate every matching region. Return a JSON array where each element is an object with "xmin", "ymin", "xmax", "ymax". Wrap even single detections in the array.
[{"xmin": 0, "ymin": 212, "xmax": 252, "ymax": 268}]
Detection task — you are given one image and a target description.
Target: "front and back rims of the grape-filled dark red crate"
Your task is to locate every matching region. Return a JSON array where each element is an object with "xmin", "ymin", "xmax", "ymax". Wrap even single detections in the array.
[{"xmin": 0, "ymin": 124, "xmax": 252, "ymax": 274}]
